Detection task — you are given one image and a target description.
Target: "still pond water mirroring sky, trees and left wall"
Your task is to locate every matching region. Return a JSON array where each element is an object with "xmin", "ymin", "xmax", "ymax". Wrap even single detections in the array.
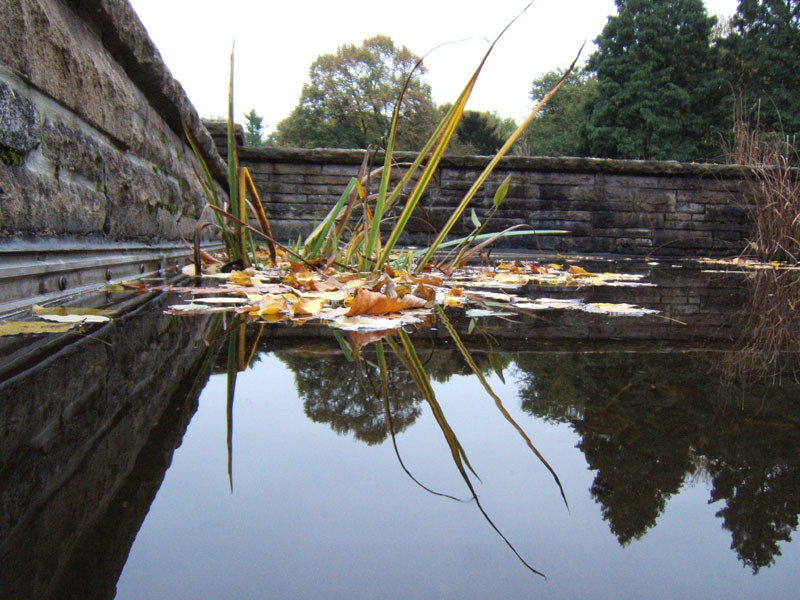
[{"xmin": 0, "ymin": 255, "xmax": 800, "ymax": 598}]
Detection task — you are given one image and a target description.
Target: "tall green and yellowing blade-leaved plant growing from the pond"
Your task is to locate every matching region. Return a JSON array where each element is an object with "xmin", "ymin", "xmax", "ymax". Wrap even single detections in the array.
[{"xmin": 187, "ymin": 2, "xmax": 580, "ymax": 274}]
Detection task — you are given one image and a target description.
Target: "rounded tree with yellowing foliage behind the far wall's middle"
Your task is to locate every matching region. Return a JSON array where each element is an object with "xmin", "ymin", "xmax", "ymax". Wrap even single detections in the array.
[{"xmin": 275, "ymin": 35, "xmax": 434, "ymax": 149}]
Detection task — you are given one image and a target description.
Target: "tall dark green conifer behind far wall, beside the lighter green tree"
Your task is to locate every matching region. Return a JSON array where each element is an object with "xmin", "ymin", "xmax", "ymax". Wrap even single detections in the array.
[{"xmin": 583, "ymin": 0, "xmax": 726, "ymax": 161}]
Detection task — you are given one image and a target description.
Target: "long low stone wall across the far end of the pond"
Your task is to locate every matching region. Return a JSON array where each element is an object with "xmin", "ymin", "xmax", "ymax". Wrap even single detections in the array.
[{"xmin": 239, "ymin": 148, "xmax": 749, "ymax": 256}]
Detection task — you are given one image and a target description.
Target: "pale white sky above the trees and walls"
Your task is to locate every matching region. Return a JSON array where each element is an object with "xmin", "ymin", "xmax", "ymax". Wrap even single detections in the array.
[{"xmin": 130, "ymin": 0, "xmax": 737, "ymax": 133}]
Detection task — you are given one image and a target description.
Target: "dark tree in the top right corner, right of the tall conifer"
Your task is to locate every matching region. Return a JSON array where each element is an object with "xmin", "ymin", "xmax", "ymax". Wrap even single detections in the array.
[{"xmin": 723, "ymin": 0, "xmax": 800, "ymax": 142}]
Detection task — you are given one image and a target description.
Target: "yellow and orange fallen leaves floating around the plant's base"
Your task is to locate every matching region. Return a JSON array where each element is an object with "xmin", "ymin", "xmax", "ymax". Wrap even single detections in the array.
[{"xmin": 159, "ymin": 255, "xmax": 658, "ymax": 332}]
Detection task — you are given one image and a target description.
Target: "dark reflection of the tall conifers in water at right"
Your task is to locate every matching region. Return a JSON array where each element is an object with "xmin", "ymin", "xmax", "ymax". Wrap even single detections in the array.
[{"xmin": 517, "ymin": 353, "xmax": 800, "ymax": 572}]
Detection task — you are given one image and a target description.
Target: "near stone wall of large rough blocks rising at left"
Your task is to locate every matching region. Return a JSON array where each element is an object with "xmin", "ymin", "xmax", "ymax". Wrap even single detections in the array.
[{"xmin": 0, "ymin": 0, "xmax": 225, "ymax": 304}]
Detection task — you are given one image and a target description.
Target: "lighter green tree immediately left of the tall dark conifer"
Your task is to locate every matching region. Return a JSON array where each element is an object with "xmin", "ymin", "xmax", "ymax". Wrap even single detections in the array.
[{"xmin": 524, "ymin": 69, "xmax": 597, "ymax": 156}]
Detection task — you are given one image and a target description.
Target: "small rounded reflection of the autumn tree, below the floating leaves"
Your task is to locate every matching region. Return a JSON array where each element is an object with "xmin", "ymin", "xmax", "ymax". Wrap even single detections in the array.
[{"xmin": 276, "ymin": 353, "xmax": 421, "ymax": 445}]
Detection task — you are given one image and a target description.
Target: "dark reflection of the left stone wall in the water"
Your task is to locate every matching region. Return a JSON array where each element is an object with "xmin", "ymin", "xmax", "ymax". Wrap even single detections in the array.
[{"xmin": 0, "ymin": 302, "xmax": 219, "ymax": 599}]
